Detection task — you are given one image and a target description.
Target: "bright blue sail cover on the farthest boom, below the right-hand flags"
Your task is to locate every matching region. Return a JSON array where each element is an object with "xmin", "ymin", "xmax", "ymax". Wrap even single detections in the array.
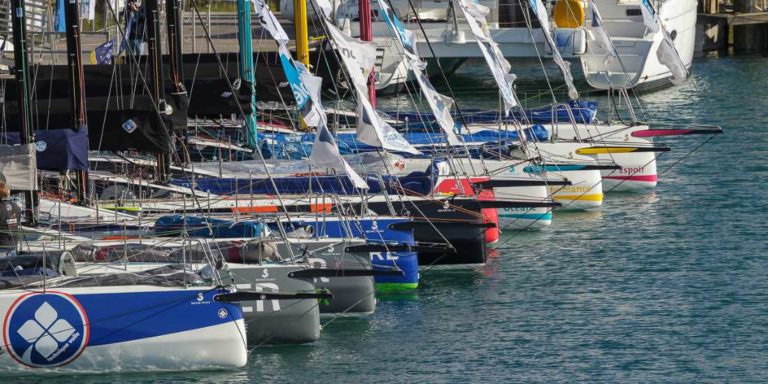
[{"xmin": 385, "ymin": 100, "xmax": 598, "ymax": 129}]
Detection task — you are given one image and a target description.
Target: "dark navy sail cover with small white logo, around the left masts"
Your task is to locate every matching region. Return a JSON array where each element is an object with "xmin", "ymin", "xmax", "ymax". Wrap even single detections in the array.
[{"xmin": 0, "ymin": 127, "xmax": 88, "ymax": 171}]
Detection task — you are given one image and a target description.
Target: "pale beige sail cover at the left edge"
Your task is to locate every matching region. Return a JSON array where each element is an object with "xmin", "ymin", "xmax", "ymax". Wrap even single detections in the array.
[{"xmin": 0, "ymin": 144, "xmax": 37, "ymax": 191}]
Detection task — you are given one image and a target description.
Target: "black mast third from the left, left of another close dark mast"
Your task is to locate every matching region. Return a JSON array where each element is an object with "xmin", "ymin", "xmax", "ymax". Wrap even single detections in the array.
[{"xmin": 144, "ymin": 0, "xmax": 171, "ymax": 182}]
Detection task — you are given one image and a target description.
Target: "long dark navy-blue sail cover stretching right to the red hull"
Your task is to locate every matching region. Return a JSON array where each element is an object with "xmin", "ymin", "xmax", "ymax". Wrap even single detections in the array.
[{"xmin": 171, "ymin": 172, "xmax": 436, "ymax": 196}]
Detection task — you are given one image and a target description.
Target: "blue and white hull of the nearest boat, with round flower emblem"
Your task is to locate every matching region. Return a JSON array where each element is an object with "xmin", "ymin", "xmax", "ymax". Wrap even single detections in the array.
[{"xmin": 0, "ymin": 286, "xmax": 247, "ymax": 374}]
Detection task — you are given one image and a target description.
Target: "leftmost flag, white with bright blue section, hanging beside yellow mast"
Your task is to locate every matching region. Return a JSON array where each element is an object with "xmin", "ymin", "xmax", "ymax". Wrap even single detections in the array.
[{"xmin": 252, "ymin": 0, "xmax": 368, "ymax": 189}]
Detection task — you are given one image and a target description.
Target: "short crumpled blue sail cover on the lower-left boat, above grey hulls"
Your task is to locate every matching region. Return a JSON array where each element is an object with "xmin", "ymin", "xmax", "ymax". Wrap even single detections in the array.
[{"xmin": 155, "ymin": 215, "xmax": 265, "ymax": 239}]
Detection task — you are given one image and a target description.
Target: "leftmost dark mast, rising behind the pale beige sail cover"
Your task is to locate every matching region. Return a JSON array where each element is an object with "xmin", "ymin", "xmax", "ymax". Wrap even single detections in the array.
[{"xmin": 11, "ymin": 0, "xmax": 37, "ymax": 225}]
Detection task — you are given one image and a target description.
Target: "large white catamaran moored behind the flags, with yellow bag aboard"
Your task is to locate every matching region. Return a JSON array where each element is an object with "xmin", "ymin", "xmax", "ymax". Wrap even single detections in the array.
[{"xmin": 316, "ymin": 0, "xmax": 697, "ymax": 92}]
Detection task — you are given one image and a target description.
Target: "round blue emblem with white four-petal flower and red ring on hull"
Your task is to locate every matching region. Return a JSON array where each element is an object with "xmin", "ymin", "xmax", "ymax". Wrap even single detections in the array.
[{"xmin": 3, "ymin": 292, "xmax": 90, "ymax": 368}]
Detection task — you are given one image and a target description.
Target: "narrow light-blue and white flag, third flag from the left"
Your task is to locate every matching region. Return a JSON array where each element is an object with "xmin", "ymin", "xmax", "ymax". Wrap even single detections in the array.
[{"xmin": 378, "ymin": 0, "xmax": 461, "ymax": 145}]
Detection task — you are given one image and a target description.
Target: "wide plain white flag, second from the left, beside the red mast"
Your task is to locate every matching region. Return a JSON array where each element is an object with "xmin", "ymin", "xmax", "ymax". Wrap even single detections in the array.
[{"xmin": 324, "ymin": 20, "xmax": 421, "ymax": 154}]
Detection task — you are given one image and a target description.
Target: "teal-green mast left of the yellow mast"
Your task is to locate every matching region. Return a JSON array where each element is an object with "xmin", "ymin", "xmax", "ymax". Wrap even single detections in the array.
[{"xmin": 237, "ymin": 0, "xmax": 258, "ymax": 149}]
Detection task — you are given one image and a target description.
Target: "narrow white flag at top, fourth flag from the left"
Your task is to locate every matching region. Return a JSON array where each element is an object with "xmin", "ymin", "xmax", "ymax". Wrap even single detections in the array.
[{"xmin": 458, "ymin": 0, "xmax": 517, "ymax": 116}]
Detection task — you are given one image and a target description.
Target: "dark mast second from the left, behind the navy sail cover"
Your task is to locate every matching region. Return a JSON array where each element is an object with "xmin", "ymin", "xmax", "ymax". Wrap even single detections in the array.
[{"xmin": 64, "ymin": 0, "xmax": 88, "ymax": 205}]
